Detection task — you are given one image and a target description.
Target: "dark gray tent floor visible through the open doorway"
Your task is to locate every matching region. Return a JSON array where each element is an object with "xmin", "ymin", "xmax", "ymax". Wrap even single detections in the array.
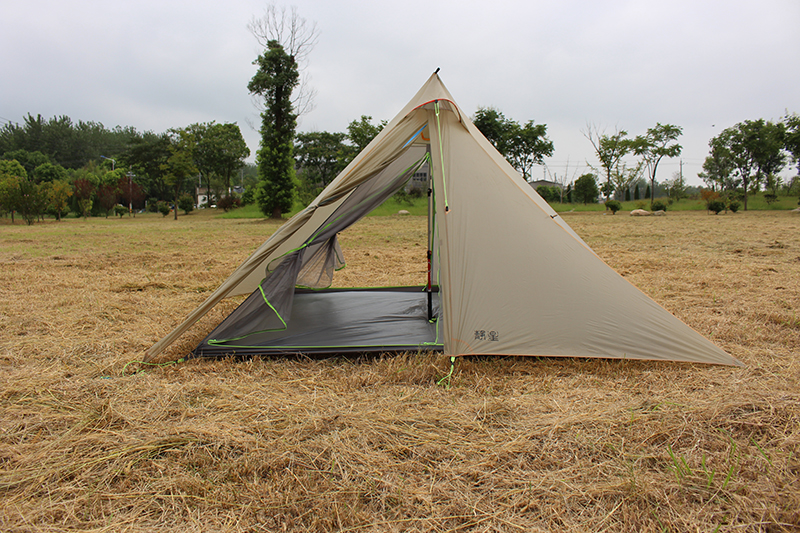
[{"xmin": 193, "ymin": 287, "xmax": 442, "ymax": 357}]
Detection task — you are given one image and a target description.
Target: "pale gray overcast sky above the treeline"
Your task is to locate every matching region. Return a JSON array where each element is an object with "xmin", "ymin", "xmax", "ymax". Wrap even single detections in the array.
[{"xmin": 0, "ymin": 0, "xmax": 800, "ymax": 184}]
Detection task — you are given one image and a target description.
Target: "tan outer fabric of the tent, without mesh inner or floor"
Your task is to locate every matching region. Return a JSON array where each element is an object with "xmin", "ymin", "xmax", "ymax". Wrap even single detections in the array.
[{"xmin": 146, "ymin": 74, "xmax": 740, "ymax": 364}]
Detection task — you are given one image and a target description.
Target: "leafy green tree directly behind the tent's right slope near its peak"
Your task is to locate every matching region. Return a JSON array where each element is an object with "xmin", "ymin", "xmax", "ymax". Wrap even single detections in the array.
[{"xmin": 473, "ymin": 107, "xmax": 554, "ymax": 181}]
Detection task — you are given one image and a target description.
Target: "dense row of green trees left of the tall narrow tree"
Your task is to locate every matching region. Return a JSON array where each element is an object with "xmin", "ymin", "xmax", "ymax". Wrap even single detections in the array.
[{"xmin": 0, "ymin": 120, "xmax": 250, "ymax": 223}]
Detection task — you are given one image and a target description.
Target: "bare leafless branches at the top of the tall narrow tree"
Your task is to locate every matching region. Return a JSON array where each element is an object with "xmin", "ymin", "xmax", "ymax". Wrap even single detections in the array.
[{"xmin": 247, "ymin": 4, "xmax": 319, "ymax": 116}]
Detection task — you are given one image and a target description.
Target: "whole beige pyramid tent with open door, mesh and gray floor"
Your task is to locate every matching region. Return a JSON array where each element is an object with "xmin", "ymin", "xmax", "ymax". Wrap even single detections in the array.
[{"xmin": 145, "ymin": 73, "xmax": 740, "ymax": 365}]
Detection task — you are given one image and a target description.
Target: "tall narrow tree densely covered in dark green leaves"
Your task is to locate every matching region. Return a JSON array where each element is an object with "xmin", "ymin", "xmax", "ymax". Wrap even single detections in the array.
[{"xmin": 247, "ymin": 41, "xmax": 299, "ymax": 218}]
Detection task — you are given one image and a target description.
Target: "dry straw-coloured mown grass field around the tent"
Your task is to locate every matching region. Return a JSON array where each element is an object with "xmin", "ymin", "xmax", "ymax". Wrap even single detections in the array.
[{"xmin": 0, "ymin": 212, "xmax": 800, "ymax": 532}]
